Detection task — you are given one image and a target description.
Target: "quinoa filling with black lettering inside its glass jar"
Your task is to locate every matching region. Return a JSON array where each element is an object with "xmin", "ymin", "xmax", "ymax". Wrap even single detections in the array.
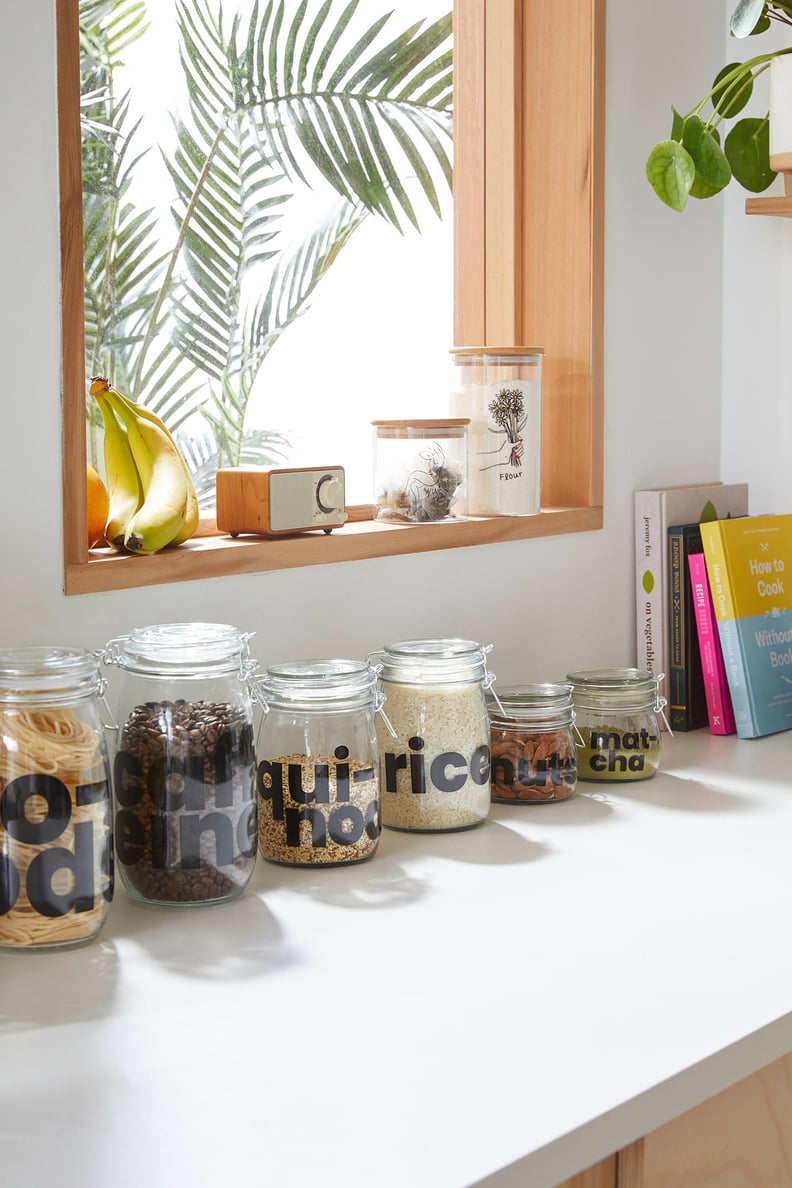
[{"xmin": 256, "ymin": 746, "xmax": 380, "ymax": 864}]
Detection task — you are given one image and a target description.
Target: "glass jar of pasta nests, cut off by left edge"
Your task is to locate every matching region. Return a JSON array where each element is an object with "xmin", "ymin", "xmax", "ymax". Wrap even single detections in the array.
[{"xmin": 0, "ymin": 646, "xmax": 113, "ymax": 949}]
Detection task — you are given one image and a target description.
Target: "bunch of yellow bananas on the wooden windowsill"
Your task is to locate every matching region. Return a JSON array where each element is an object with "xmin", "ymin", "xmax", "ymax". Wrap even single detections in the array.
[{"xmin": 89, "ymin": 375, "xmax": 198, "ymax": 554}]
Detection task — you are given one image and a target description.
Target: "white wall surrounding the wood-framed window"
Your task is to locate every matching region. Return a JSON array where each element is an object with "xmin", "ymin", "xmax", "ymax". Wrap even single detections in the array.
[{"xmin": 0, "ymin": 0, "xmax": 731, "ymax": 683}]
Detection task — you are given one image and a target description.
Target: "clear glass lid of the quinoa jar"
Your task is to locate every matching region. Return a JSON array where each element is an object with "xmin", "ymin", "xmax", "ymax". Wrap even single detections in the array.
[{"xmin": 255, "ymin": 659, "xmax": 376, "ymax": 710}]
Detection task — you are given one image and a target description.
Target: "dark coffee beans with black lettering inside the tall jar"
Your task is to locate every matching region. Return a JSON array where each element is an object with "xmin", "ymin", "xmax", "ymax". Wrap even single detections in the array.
[{"xmin": 114, "ymin": 701, "xmax": 255, "ymax": 903}]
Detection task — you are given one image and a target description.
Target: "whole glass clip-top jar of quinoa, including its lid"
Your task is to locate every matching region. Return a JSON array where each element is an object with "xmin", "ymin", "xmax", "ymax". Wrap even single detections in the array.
[{"xmin": 255, "ymin": 659, "xmax": 381, "ymax": 866}]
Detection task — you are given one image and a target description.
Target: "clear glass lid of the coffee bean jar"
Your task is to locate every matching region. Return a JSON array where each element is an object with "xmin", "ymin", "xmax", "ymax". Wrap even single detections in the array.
[{"xmin": 104, "ymin": 623, "xmax": 254, "ymax": 676}]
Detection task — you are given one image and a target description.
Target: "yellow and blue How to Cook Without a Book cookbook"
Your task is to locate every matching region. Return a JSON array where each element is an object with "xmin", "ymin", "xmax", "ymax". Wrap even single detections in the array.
[{"xmin": 701, "ymin": 513, "xmax": 792, "ymax": 738}]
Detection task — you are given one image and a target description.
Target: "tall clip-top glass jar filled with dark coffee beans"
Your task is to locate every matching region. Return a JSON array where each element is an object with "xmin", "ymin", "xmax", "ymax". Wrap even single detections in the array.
[{"xmin": 104, "ymin": 623, "xmax": 255, "ymax": 908}]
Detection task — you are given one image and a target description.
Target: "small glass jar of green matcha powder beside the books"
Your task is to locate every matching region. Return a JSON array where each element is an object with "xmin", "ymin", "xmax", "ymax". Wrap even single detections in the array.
[{"xmin": 566, "ymin": 668, "xmax": 665, "ymax": 782}]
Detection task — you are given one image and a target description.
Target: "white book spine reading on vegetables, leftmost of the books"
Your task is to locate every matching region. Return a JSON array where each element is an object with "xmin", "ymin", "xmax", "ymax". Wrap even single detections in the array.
[{"xmin": 634, "ymin": 491, "xmax": 667, "ymax": 696}]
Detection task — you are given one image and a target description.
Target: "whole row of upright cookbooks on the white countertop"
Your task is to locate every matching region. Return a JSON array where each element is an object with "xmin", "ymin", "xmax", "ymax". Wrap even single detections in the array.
[{"xmin": 635, "ymin": 484, "xmax": 792, "ymax": 738}]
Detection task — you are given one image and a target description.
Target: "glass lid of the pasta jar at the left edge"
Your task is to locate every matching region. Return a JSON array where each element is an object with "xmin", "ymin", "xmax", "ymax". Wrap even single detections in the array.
[{"xmin": 0, "ymin": 646, "xmax": 104, "ymax": 706}]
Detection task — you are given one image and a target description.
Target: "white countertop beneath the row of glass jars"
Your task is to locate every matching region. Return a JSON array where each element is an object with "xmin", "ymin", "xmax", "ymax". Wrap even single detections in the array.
[{"xmin": 0, "ymin": 731, "xmax": 792, "ymax": 1188}]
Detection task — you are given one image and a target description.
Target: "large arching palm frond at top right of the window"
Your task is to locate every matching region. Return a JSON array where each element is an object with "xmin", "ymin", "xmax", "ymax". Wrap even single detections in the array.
[{"xmin": 235, "ymin": 0, "xmax": 452, "ymax": 229}]
